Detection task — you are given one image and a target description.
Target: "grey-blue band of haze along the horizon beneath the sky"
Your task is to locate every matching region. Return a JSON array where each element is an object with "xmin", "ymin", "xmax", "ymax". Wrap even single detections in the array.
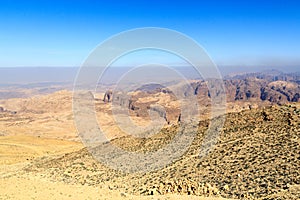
[{"xmin": 0, "ymin": 66, "xmax": 300, "ymax": 84}]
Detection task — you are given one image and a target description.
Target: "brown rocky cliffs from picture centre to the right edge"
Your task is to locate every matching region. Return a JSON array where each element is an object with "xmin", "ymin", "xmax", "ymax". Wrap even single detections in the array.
[{"xmin": 104, "ymin": 71, "xmax": 300, "ymax": 123}]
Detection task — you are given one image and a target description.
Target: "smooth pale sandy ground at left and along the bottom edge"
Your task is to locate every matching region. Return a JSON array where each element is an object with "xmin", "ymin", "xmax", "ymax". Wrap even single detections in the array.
[{"xmin": 0, "ymin": 91, "xmax": 232, "ymax": 199}]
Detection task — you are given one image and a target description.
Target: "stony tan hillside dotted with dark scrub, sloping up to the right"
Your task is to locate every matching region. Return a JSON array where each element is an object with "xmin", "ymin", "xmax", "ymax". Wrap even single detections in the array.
[{"xmin": 25, "ymin": 104, "xmax": 300, "ymax": 199}]
